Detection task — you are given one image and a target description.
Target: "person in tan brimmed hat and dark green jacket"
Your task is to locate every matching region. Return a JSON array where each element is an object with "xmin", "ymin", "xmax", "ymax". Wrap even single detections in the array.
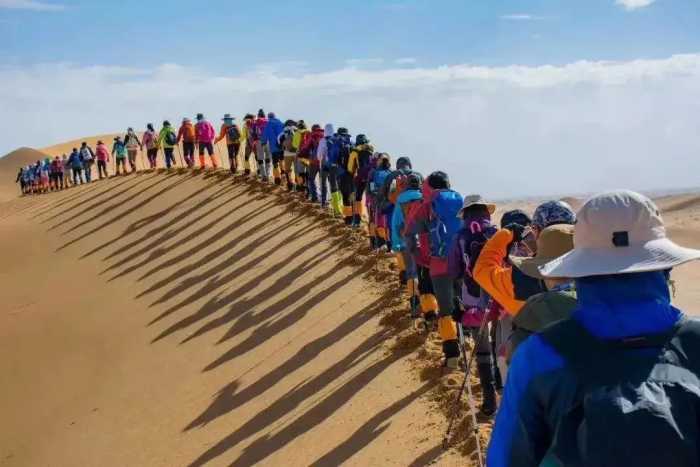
[{"xmin": 507, "ymin": 224, "xmax": 577, "ymax": 364}]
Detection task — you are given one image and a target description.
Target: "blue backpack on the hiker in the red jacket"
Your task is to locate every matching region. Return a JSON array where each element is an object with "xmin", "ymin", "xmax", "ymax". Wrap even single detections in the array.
[{"xmin": 429, "ymin": 190, "xmax": 463, "ymax": 258}]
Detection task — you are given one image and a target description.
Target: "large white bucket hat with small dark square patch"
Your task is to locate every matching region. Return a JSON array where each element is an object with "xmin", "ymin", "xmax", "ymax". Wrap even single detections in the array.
[{"xmin": 540, "ymin": 190, "xmax": 700, "ymax": 278}]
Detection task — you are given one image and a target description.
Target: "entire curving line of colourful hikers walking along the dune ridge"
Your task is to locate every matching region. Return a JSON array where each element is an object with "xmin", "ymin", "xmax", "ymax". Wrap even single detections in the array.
[{"xmin": 12, "ymin": 110, "xmax": 700, "ymax": 466}]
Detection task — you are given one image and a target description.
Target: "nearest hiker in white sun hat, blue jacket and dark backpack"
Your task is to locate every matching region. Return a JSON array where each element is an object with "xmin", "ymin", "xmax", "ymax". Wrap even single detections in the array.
[{"xmin": 487, "ymin": 190, "xmax": 700, "ymax": 467}]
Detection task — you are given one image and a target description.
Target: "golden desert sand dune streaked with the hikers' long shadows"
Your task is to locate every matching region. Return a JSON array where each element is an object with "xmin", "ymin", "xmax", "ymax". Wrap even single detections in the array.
[{"xmin": 0, "ymin": 140, "xmax": 700, "ymax": 466}]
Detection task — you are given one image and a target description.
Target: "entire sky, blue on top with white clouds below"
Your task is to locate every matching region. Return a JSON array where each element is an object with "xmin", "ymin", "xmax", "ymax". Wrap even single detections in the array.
[{"xmin": 0, "ymin": 0, "xmax": 700, "ymax": 198}]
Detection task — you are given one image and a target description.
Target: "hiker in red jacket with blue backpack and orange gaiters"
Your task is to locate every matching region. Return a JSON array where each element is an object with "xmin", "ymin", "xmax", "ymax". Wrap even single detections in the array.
[{"xmin": 404, "ymin": 170, "xmax": 463, "ymax": 370}]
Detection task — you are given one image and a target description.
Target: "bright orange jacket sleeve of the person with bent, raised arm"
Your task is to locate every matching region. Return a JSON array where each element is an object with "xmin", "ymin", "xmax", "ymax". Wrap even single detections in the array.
[{"xmin": 474, "ymin": 229, "xmax": 525, "ymax": 316}]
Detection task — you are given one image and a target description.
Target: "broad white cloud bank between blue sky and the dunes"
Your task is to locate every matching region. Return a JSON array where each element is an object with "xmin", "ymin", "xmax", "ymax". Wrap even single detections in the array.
[{"xmin": 0, "ymin": 54, "xmax": 700, "ymax": 197}]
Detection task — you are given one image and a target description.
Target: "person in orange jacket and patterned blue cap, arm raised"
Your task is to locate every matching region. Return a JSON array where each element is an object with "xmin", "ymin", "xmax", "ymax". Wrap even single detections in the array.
[{"xmin": 474, "ymin": 201, "xmax": 576, "ymax": 316}]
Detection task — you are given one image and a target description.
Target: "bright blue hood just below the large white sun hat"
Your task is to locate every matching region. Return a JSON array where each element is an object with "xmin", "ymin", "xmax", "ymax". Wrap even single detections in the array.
[{"xmin": 574, "ymin": 271, "xmax": 682, "ymax": 338}]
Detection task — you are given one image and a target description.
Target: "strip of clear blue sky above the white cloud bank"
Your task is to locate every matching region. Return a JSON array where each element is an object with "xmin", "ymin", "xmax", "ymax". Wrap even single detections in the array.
[{"xmin": 0, "ymin": 0, "xmax": 700, "ymax": 72}]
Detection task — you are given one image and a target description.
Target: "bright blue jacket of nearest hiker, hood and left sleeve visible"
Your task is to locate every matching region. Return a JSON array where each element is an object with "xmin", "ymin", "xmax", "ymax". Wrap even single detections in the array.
[{"xmin": 487, "ymin": 272, "xmax": 683, "ymax": 467}]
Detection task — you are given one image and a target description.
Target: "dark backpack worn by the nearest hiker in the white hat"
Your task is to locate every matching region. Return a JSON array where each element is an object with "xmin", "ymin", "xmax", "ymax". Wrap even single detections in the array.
[{"xmin": 536, "ymin": 318, "xmax": 700, "ymax": 467}]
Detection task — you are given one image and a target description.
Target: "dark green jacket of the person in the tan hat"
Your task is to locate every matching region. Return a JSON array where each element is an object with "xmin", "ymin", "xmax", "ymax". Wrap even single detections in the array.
[{"xmin": 507, "ymin": 290, "xmax": 577, "ymax": 362}]
